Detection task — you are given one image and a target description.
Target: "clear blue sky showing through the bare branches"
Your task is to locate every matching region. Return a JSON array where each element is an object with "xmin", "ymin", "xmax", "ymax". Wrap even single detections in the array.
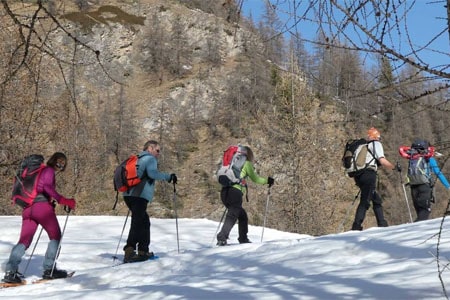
[{"xmin": 243, "ymin": 0, "xmax": 450, "ymax": 71}]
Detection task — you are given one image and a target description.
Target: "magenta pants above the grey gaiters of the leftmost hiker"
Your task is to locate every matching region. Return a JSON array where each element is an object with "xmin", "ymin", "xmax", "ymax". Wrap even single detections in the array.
[{"xmin": 19, "ymin": 202, "xmax": 61, "ymax": 249}]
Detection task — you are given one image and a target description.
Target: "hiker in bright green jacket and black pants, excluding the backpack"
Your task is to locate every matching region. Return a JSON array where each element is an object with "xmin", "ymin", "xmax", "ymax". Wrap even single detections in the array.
[{"xmin": 217, "ymin": 146, "xmax": 275, "ymax": 246}]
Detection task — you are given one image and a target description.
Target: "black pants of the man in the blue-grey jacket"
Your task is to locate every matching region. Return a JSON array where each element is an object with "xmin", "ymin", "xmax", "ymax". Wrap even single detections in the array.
[{"xmin": 124, "ymin": 196, "xmax": 150, "ymax": 252}]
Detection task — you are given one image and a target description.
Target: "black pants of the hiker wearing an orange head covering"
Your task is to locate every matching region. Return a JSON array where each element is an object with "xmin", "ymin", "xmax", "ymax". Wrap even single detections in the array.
[{"xmin": 352, "ymin": 169, "xmax": 388, "ymax": 230}]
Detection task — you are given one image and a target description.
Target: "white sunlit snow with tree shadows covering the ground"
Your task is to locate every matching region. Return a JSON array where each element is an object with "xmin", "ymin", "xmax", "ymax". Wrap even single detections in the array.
[{"xmin": 0, "ymin": 215, "xmax": 450, "ymax": 300}]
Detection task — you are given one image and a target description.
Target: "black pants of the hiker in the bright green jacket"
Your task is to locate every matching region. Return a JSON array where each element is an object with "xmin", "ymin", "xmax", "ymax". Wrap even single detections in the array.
[{"xmin": 217, "ymin": 187, "xmax": 248, "ymax": 242}]
